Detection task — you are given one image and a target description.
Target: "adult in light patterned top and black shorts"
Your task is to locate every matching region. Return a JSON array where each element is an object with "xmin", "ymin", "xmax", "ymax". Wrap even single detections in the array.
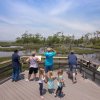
[{"xmin": 26, "ymin": 51, "xmax": 40, "ymax": 81}]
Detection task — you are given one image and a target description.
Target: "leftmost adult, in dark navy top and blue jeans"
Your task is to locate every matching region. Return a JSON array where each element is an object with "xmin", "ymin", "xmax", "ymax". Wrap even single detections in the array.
[{"xmin": 12, "ymin": 50, "xmax": 21, "ymax": 81}]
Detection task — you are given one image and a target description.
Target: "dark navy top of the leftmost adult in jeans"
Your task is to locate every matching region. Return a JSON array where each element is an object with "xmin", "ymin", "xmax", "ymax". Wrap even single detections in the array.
[{"xmin": 12, "ymin": 53, "xmax": 20, "ymax": 67}]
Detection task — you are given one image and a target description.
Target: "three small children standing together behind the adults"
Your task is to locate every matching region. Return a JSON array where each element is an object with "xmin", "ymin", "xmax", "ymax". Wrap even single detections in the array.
[{"xmin": 38, "ymin": 68, "xmax": 65, "ymax": 99}]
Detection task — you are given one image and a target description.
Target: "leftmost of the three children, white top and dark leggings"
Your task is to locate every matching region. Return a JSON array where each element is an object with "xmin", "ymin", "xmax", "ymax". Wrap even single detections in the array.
[{"xmin": 38, "ymin": 68, "xmax": 45, "ymax": 99}]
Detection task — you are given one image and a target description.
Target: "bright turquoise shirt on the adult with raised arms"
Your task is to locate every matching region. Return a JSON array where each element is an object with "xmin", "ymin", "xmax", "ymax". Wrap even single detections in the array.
[{"xmin": 44, "ymin": 52, "xmax": 56, "ymax": 66}]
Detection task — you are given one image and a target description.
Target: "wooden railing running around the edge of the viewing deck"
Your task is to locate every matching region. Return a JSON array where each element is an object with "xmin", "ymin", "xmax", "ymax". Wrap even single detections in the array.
[{"xmin": 0, "ymin": 56, "xmax": 100, "ymax": 81}]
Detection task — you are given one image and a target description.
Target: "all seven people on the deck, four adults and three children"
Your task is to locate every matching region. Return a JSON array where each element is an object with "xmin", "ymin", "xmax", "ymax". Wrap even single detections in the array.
[{"xmin": 12, "ymin": 48, "xmax": 77, "ymax": 99}]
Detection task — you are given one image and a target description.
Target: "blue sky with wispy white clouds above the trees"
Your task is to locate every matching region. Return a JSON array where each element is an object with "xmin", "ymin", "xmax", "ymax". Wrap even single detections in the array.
[{"xmin": 0, "ymin": 0, "xmax": 100, "ymax": 41}]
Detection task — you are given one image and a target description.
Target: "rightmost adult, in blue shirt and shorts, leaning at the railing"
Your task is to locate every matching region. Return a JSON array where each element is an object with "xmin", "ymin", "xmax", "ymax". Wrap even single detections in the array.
[{"xmin": 68, "ymin": 51, "xmax": 77, "ymax": 83}]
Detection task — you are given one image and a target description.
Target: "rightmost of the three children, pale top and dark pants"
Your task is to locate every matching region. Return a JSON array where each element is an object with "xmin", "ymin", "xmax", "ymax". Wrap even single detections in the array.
[{"xmin": 54, "ymin": 69, "xmax": 64, "ymax": 97}]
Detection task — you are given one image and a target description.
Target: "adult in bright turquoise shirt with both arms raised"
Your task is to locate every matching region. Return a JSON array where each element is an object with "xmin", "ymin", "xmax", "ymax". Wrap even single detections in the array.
[{"xmin": 44, "ymin": 48, "xmax": 56, "ymax": 73}]
